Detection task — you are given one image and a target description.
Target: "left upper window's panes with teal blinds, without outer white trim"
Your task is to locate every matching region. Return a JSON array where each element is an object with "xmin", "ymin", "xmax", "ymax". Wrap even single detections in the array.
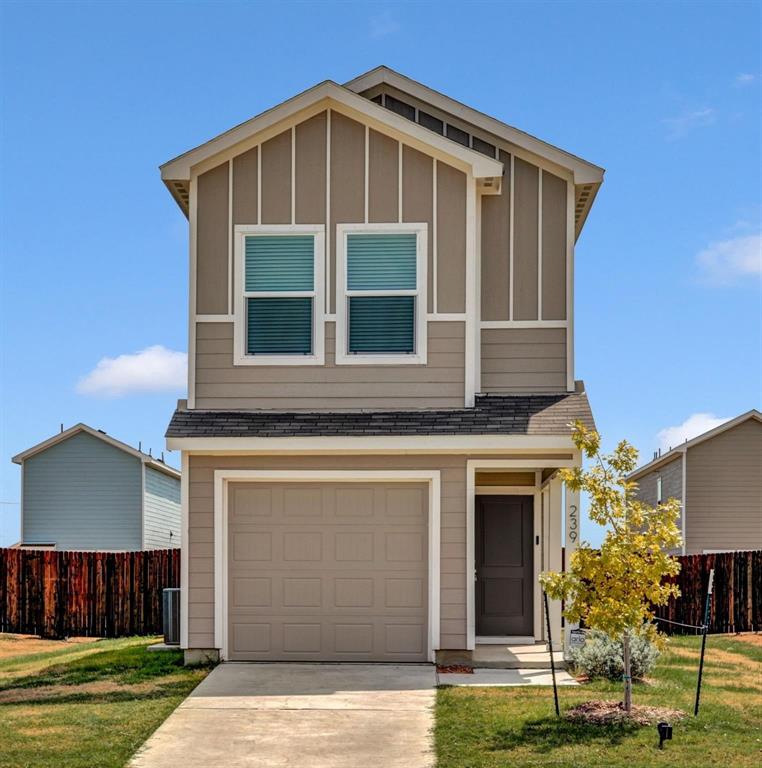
[{"xmin": 244, "ymin": 235, "xmax": 315, "ymax": 355}]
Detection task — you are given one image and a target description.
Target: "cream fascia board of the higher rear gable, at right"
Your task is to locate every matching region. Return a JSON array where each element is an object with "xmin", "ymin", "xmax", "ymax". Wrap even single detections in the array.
[{"xmin": 344, "ymin": 66, "xmax": 605, "ymax": 184}]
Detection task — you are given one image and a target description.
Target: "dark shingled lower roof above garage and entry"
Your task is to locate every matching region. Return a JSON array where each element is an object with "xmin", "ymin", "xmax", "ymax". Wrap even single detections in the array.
[{"xmin": 166, "ymin": 391, "xmax": 595, "ymax": 438}]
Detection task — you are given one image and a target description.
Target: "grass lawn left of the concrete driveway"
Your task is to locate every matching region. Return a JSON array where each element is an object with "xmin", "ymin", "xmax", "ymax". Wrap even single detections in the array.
[{"xmin": 0, "ymin": 636, "xmax": 209, "ymax": 768}]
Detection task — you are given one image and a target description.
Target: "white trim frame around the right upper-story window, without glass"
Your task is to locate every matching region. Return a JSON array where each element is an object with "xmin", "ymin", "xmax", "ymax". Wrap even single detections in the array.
[{"xmin": 336, "ymin": 222, "xmax": 428, "ymax": 365}]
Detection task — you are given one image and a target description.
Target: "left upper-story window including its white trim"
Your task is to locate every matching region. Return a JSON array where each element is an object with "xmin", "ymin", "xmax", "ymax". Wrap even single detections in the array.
[{"xmin": 234, "ymin": 225, "xmax": 324, "ymax": 365}]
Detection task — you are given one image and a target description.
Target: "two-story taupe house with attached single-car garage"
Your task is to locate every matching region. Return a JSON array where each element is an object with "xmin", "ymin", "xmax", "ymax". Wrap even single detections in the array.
[{"xmin": 161, "ymin": 67, "xmax": 603, "ymax": 661}]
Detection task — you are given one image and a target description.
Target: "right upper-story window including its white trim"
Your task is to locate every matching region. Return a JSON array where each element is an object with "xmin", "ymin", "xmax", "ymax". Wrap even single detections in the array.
[{"xmin": 336, "ymin": 224, "xmax": 427, "ymax": 365}]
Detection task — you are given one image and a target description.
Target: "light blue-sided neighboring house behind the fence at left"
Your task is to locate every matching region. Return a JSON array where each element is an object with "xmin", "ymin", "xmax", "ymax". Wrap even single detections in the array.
[{"xmin": 13, "ymin": 424, "xmax": 181, "ymax": 550}]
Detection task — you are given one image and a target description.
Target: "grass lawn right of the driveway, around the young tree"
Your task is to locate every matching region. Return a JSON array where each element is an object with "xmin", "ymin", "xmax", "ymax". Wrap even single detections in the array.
[{"xmin": 435, "ymin": 636, "xmax": 762, "ymax": 768}]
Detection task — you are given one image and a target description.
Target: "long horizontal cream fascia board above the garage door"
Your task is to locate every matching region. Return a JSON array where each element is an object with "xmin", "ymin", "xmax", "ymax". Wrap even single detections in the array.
[{"xmin": 167, "ymin": 435, "xmax": 575, "ymax": 454}]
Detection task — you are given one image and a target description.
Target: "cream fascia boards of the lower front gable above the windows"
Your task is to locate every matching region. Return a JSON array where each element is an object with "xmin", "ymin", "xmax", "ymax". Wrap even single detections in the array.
[{"xmin": 160, "ymin": 80, "xmax": 503, "ymax": 181}]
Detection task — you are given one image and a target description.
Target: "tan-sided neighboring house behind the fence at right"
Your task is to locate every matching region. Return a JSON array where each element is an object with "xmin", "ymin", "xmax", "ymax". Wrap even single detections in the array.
[{"xmin": 629, "ymin": 410, "xmax": 762, "ymax": 555}]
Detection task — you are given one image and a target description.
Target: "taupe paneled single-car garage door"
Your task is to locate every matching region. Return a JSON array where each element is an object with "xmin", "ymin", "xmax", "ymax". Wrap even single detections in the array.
[{"xmin": 228, "ymin": 482, "xmax": 428, "ymax": 661}]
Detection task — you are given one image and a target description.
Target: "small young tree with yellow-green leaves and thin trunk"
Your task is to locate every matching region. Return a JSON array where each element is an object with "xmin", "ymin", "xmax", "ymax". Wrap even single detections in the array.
[{"xmin": 540, "ymin": 422, "xmax": 680, "ymax": 712}]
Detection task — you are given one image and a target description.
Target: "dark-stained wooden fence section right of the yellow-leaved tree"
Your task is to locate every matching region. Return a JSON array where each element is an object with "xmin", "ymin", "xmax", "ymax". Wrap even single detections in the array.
[{"xmin": 656, "ymin": 551, "xmax": 762, "ymax": 634}]
